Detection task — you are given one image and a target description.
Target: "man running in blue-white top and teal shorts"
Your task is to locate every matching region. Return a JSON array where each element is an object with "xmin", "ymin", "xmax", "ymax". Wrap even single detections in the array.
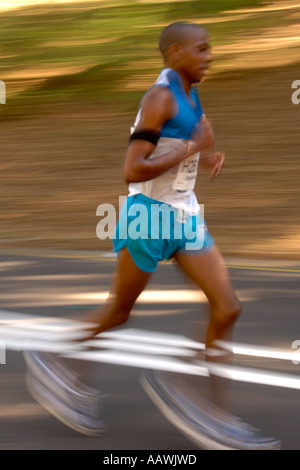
[{"xmin": 27, "ymin": 22, "xmax": 279, "ymax": 449}]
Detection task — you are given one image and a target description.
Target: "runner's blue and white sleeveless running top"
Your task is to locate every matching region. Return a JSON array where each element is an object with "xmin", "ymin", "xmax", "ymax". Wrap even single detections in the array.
[{"xmin": 129, "ymin": 68, "xmax": 203, "ymax": 215}]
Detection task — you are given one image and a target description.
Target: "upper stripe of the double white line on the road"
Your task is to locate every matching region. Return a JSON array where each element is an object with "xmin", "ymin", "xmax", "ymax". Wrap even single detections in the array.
[{"xmin": 0, "ymin": 311, "xmax": 300, "ymax": 368}]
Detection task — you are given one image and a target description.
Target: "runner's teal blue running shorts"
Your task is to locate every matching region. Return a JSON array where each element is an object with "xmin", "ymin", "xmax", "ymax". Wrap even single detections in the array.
[{"xmin": 113, "ymin": 194, "xmax": 214, "ymax": 272}]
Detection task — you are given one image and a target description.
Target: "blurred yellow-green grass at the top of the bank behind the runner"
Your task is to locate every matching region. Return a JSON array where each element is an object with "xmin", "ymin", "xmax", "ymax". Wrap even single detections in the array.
[{"xmin": 0, "ymin": 0, "xmax": 283, "ymax": 113}]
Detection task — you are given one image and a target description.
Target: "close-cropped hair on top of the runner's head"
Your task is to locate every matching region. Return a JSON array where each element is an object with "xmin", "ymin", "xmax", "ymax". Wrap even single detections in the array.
[{"xmin": 159, "ymin": 22, "xmax": 206, "ymax": 59}]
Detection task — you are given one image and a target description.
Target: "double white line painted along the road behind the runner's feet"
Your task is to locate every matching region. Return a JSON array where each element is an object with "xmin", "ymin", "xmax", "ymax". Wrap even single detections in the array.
[{"xmin": 0, "ymin": 311, "xmax": 300, "ymax": 390}]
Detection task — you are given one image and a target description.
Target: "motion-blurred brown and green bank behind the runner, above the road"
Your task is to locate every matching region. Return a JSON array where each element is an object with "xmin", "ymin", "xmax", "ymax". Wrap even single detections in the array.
[{"xmin": 0, "ymin": 0, "xmax": 300, "ymax": 258}]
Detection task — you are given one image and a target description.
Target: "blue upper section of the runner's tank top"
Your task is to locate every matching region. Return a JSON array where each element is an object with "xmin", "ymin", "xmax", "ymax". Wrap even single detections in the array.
[{"xmin": 151, "ymin": 68, "xmax": 203, "ymax": 140}]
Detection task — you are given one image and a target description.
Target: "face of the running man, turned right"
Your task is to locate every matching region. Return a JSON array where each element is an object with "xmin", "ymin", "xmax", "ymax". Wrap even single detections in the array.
[{"xmin": 179, "ymin": 29, "xmax": 212, "ymax": 83}]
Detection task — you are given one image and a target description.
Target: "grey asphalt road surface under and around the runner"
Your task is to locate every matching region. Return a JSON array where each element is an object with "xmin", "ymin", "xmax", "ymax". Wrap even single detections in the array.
[{"xmin": 0, "ymin": 250, "xmax": 300, "ymax": 451}]
